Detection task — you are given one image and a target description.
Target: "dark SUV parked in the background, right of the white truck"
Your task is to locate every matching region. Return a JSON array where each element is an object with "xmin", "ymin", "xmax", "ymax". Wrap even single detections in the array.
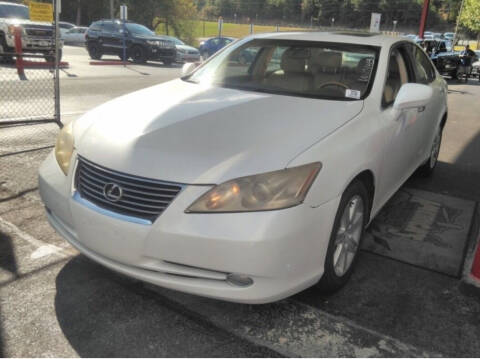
[{"xmin": 85, "ymin": 20, "xmax": 177, "ymax": 65}]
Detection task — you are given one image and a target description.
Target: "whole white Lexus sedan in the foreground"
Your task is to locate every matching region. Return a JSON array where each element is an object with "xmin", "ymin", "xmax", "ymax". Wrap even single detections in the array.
[{"xmin": 40, "ymin": 32, "xmax": 447, "ymax": 303}]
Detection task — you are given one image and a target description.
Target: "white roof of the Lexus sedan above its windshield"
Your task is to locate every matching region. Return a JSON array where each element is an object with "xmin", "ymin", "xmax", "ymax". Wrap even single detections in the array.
[{"xmin": 251, "ymin": 31, "xmax": 407, "ymax": 47}]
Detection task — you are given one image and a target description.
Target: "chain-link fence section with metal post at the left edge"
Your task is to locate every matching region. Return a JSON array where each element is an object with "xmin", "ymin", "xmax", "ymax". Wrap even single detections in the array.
[{"xmin": 0, "ymin": 6, "xmax": 61, "ymax": 201}]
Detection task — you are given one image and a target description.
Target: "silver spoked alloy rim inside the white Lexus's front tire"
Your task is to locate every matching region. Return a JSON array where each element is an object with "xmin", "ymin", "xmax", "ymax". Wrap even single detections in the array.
[{"xmin": 333, "ymin": 195, "xmax": 365, "ymax": 277}]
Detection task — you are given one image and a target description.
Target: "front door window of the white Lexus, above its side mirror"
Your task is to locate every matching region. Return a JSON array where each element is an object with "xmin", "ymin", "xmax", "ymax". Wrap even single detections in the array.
[{"xmin": 382, "ymin": 49, "xmax": 408, "ymax": 107}]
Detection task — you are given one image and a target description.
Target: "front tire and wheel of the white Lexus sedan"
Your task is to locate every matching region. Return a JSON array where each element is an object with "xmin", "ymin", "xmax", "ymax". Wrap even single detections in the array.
[{"xmin": 317, "ymin": 180, "xmax": 370, "ymax": 293}]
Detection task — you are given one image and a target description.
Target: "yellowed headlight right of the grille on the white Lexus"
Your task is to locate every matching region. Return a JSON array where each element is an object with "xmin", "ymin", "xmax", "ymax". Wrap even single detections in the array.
[{"xmin": 185, "ymin": 162, "xmax": 322, "ymax": 213}]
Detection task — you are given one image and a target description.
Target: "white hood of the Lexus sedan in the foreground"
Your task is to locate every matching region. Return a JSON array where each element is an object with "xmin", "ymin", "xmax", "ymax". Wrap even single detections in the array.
[{"xmin": 74, "ymin": 79, "xmax": 363, "ymax": 184}]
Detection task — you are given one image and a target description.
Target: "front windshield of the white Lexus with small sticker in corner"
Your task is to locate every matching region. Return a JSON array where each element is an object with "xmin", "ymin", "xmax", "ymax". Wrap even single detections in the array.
[{"xmin": 183, "ymin": 39, "xmax": 379, "ymax": 100}]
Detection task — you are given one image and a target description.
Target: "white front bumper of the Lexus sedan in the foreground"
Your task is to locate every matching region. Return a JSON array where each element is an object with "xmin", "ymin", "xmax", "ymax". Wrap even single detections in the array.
[{"xmin": 39, "ymin": 154, "xmax": 339, "ymax": 303}]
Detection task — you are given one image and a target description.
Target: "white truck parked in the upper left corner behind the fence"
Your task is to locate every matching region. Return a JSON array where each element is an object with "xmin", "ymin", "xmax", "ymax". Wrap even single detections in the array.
[{"xmin": 0, "ymin": 1, "xmax": 63, "ymax": 62}]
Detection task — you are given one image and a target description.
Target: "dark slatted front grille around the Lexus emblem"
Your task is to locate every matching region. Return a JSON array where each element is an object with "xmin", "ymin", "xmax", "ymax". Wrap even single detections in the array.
[{"xmin": 75, "ymin": 156, "xmax": 182, "ymax": 222}]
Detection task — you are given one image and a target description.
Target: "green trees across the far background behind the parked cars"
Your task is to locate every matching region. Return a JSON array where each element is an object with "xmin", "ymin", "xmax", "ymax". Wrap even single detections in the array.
[{"xmin": 55, "ymin": 0, "xmax": 464, "ymax": 36}]
